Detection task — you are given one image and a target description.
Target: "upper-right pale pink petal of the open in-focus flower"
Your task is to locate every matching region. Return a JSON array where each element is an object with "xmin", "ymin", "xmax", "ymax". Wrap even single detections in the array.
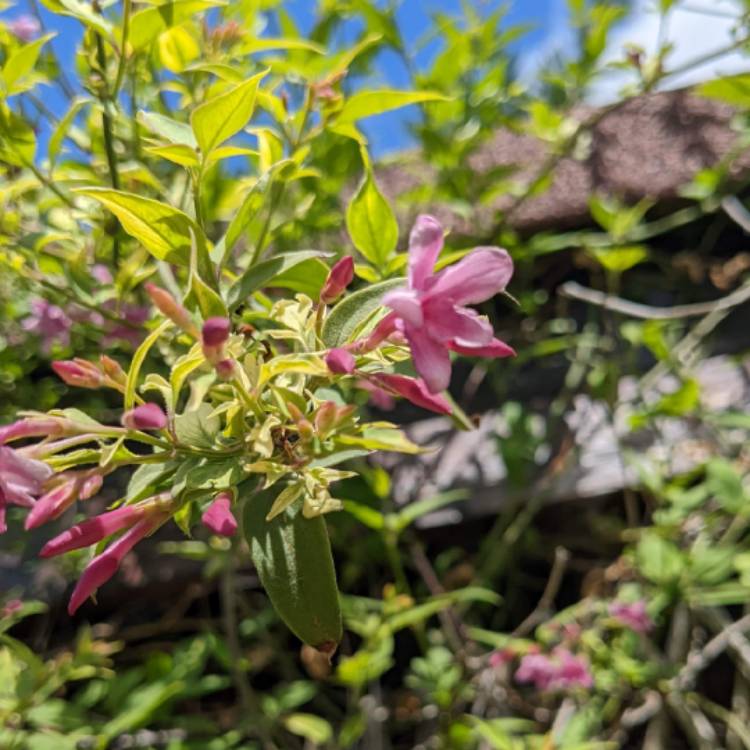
[{"xmin": 427, "ymin": 247, "xmax": 513, "ymax": 305}]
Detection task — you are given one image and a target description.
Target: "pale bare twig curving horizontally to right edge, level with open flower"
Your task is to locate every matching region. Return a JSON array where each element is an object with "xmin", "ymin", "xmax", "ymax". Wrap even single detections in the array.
[{"xmin": 557, "ymin": 281, "xmax": 750, "ymax": 320}]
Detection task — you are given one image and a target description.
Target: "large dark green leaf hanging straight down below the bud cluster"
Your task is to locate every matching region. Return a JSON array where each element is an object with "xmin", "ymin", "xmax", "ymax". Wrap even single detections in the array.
[{"xmin": 238, "ymin": 482, "xmax": 342, "ymax": 655}]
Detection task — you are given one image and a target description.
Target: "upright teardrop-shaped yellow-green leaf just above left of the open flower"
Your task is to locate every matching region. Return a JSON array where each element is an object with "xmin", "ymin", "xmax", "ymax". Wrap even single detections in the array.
[{"xmin": 346, "ymin": 170, "xmax": 398, "ymax": 269}]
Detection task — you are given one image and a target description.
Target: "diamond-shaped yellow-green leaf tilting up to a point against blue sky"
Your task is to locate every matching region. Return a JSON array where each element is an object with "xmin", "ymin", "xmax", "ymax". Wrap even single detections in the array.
[{"xmin": 190, "ymin": 71, "xmax": 268, "ymax": 156}]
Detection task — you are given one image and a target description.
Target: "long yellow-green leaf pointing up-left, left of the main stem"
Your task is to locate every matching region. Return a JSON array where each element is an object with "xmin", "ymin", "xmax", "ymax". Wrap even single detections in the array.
[{"xmin": 75, "ymin": 187, "xmax": 194, "ymax": 265}]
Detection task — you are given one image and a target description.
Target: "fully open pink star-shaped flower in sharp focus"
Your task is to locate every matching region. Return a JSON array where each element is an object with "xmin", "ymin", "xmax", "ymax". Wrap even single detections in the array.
[{"xmin": 380, "ymin": 216, "xmax": 514, "ymax": 393}]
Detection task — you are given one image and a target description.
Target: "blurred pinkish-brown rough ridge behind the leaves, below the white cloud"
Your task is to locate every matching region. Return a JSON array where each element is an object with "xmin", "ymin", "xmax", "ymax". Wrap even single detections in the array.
[{"xmin": 381, "ymin": 90, "xmax": 750, "ymax": 237}]
